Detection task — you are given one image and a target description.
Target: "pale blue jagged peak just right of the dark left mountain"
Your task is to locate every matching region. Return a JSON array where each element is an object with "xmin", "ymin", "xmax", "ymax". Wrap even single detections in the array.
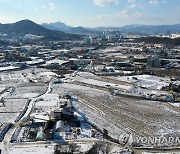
[{"xmin": 41, "ymin": 22, "xmax": 73, "ymax": 31}]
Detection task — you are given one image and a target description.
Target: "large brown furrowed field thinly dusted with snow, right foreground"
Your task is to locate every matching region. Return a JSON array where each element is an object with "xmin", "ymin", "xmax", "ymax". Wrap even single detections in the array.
[{"xmin": 52, "ymin": 83, "xmax": 180, "ymax": 141}]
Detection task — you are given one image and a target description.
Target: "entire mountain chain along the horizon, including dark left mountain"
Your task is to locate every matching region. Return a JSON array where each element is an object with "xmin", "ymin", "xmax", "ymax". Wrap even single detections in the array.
[{"xmin": 3, "ymin": 20, "xmax": 180, "ymax": 40}]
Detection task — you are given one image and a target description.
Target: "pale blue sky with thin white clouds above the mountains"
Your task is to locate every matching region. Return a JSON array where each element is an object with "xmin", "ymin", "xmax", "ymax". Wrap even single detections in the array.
[{"xmin": 0, "ymin": 0, "xmax": 180, "ymax": 27}]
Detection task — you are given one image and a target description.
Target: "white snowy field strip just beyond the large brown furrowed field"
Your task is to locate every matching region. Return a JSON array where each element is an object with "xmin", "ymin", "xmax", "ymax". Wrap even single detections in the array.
[{"xmin": 65, "ymin": 72, "xmax": 170, "ymax": 99}]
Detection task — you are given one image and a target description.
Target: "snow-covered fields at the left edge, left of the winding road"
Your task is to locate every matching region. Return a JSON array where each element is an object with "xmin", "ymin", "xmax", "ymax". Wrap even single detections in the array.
[{"xmin": 0, "ymin": 68, "xmax": 54, "ymax": 131}]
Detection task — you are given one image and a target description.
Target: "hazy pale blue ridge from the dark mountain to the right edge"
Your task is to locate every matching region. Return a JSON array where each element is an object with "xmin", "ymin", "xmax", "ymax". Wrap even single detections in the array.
[{"xmin": 42, "ymin": 22, "xmax": 180, "ymax": 34}]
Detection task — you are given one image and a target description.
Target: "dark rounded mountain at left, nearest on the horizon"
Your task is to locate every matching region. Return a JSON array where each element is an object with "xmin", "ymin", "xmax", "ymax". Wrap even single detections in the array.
[{"xmin": 0, "ymin": 20, "xmax": 80, "ymax": 40}]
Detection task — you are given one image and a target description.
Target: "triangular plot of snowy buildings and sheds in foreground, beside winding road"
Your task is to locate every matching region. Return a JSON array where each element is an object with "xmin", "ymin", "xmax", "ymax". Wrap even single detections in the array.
[{"xmin": 11, "ymin": 93, "xmax": 103, "ymax": 143}]
